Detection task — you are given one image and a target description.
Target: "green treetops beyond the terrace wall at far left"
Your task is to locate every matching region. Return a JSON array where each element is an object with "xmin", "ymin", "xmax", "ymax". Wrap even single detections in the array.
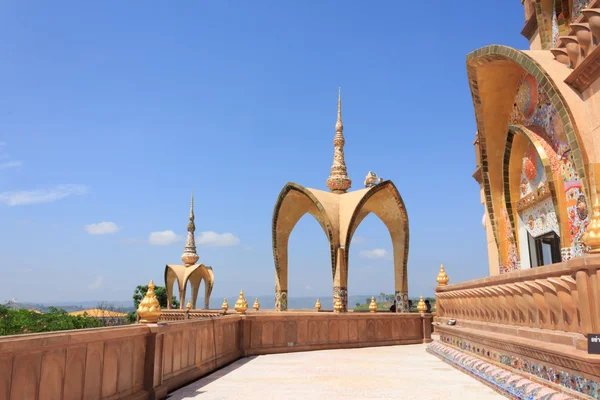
[{"xmin": 0, "ymin": 305, "xmax": 103, "ymax": 336}]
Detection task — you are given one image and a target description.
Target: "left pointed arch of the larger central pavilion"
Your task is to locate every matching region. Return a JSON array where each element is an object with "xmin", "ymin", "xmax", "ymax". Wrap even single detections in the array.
[{"xmin": 272, "ymin": 182, "xmax": 338, "ymax": 311}]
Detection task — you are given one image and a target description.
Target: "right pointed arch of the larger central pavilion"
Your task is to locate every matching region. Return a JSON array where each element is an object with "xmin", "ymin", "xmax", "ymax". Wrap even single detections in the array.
[{"xmin": 344, "ymin": 180, "xmax": 409, "ymax": 312}]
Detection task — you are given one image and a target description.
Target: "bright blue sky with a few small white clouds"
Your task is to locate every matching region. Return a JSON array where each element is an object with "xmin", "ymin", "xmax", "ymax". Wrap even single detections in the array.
[{"xmin": 0, "ymin": 0, "xmax": 528, "ymax": 302}]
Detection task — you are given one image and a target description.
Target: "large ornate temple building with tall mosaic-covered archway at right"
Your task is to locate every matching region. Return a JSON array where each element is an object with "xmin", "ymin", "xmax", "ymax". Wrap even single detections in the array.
[{"xmin": 467, "ymin": 0, "xmax": 600, "ymax": 275}]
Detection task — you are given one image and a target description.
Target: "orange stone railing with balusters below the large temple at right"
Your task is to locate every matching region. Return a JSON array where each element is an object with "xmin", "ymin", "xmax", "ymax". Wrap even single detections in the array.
[{"xmin": 436, "ymin": 256, "xmax": 600, "ymax": 336}]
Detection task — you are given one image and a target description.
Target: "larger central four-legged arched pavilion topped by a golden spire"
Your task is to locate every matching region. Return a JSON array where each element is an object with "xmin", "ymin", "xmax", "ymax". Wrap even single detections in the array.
[{"xmin": 272, "ymin": 91, "xmax": 408, "ymax": 312}]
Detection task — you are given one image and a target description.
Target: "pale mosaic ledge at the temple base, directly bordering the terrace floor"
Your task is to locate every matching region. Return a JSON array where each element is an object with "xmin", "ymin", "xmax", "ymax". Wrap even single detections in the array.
[{"xmin": 427, "ymin": 341, "xmax": 575, "ymax": 400}]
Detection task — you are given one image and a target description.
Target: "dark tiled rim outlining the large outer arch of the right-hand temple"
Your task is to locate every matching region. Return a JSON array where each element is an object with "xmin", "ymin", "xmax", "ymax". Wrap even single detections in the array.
[{"xmin": 467, "ymin": 44, "xmax": 592, "ymax": 268}]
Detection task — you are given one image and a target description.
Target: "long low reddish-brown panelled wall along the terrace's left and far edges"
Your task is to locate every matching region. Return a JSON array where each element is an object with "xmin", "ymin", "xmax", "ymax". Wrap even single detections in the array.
[{"xmin": 0, "ymin": 310, "xmax": 431, "ymax": 400}]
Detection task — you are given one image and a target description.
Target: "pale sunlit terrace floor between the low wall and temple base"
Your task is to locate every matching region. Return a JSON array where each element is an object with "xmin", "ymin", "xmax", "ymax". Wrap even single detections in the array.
[{"xmin": 168, "ymin": 344, "xmax": 505, "ymax": 400}]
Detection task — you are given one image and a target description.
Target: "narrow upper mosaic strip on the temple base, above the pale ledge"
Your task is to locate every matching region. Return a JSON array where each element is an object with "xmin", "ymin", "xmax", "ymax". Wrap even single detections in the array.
[{"xmin": 441, "ymin": 335, "xmax": 600, "ymax": 399}]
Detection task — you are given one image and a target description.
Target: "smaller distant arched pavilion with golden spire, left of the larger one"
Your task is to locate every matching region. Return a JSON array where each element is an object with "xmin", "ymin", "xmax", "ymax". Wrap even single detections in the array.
[{"xmin": 165, "ymin": 193, "xmax": 215, "ymax": 309}]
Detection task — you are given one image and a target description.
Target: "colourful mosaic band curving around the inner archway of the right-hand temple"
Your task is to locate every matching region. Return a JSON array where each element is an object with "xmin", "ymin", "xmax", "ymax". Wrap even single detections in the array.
[{"xmin": 509, "ymin": 74, "xmax": 588, "ymax": 261}]
